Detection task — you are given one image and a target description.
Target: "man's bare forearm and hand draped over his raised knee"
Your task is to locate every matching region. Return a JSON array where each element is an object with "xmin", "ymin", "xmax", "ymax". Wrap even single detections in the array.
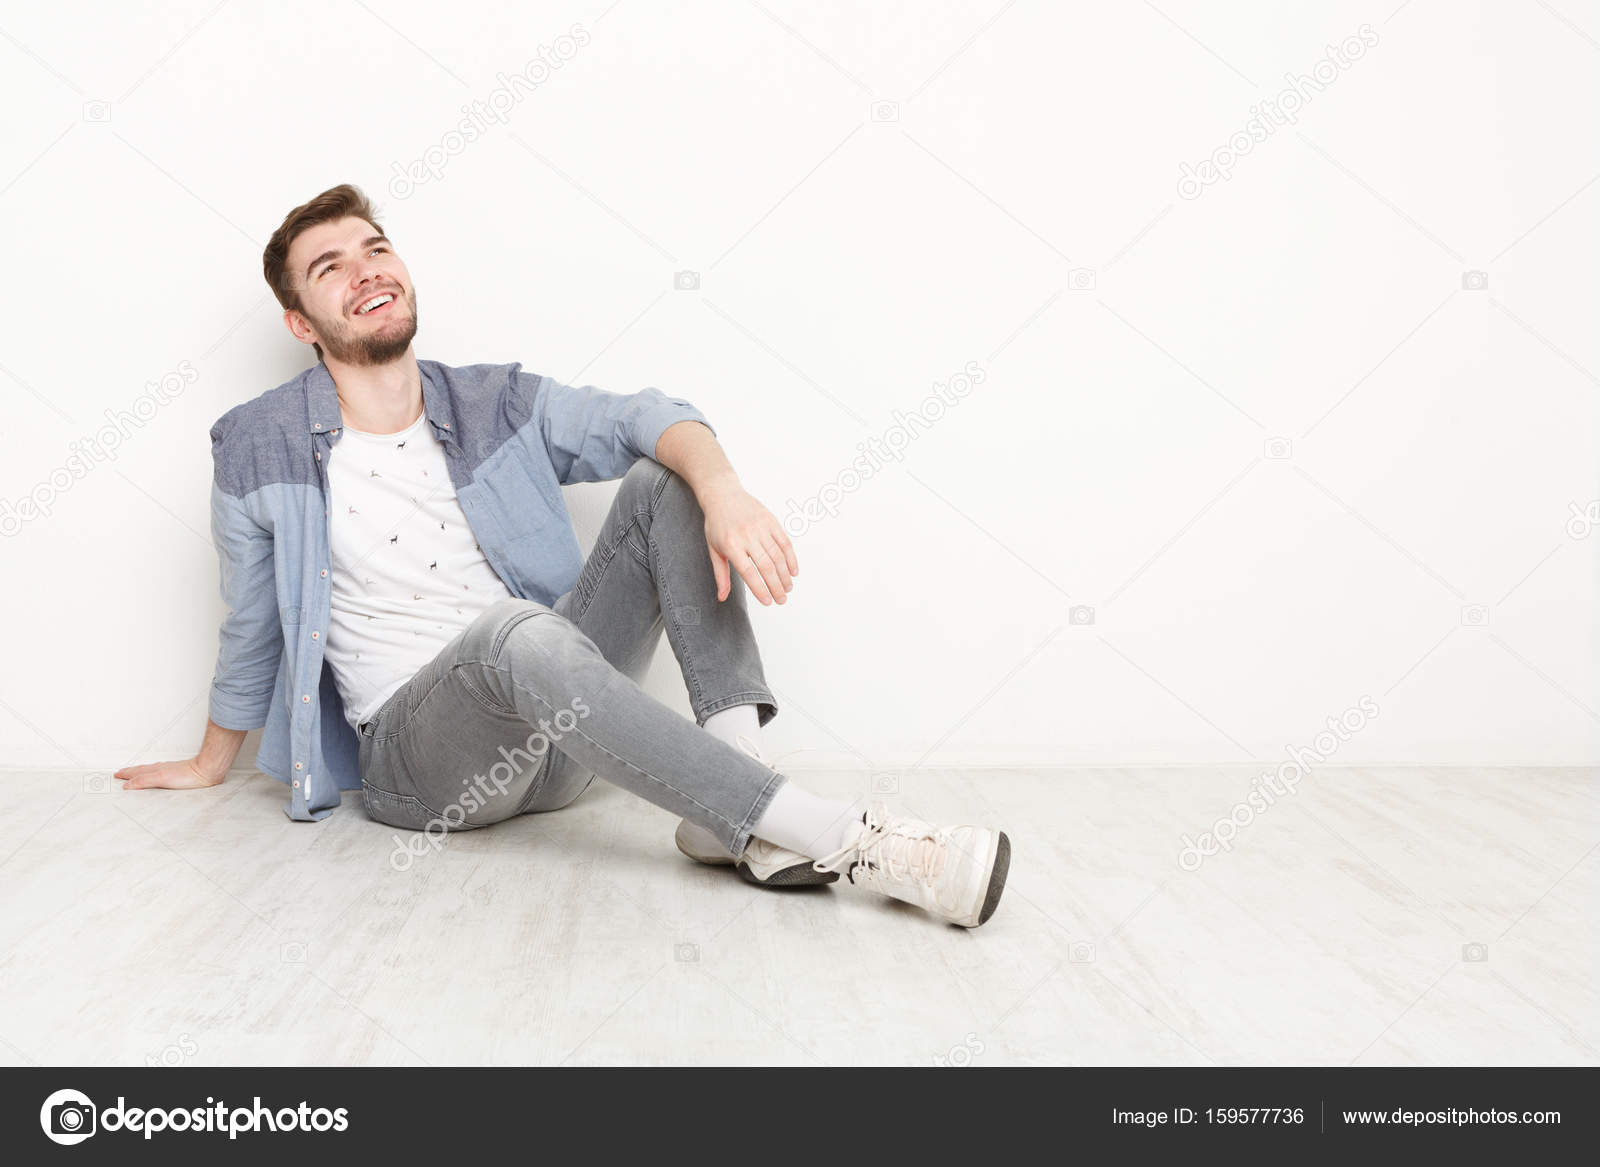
[{"xmin": 654, "ymin": 421, "xmax": 800, "ymax": 605}]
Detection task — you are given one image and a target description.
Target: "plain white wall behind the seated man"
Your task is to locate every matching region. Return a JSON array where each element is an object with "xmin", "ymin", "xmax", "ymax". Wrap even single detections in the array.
[{"xmin": 0, "ymin": 0, "xmax": 1600, "ymax": 767}]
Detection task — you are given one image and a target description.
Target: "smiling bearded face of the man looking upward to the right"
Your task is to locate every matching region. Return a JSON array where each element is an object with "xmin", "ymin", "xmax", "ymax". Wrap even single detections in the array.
[{"xmin": 285, "ymin": 218, "xmax": 416, "ymax": 365}]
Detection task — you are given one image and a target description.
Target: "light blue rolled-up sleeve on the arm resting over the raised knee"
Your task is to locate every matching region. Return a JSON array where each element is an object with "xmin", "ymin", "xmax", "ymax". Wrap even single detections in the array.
[{"xmin": 514, "ymin": 370, "xmax": 717, "ymax": 485}]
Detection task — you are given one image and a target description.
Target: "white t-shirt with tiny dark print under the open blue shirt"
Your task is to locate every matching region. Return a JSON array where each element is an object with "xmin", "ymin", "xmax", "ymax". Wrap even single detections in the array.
[{"xmin": 323, "ymin": 413, "xmax": 512, "ymax": 730}]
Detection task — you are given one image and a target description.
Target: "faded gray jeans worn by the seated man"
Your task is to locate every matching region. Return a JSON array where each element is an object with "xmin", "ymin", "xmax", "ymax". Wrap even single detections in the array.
[{"xmin": 360, "ymin": 458, "xmax": 786, "ymax": 855}]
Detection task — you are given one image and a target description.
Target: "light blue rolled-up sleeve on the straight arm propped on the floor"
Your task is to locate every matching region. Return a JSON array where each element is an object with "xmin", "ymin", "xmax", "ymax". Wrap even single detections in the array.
[{"xmin": 210, "ymin": 483, "xmax": 283, "ymax": 730}]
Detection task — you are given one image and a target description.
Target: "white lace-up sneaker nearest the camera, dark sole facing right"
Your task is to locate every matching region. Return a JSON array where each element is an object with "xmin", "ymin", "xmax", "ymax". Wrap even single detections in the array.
[{"xmin": 811, "ymin": 802, "xmax": 1011, "ymax": 928}]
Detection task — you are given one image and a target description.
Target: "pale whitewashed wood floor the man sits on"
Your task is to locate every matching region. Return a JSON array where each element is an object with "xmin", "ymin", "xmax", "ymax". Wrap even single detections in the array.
[{"xmin": 0, "ymin": 767, "xmax": 1600, "ymax": 1066}]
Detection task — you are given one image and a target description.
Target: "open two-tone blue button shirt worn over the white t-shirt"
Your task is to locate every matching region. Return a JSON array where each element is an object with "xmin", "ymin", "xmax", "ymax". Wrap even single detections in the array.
[{"xmin": 210, "ymin": 360, "xmax": 715, "ymax": 821}]
